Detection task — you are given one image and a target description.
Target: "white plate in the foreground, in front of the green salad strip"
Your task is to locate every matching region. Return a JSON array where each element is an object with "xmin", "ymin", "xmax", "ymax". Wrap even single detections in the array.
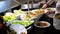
[{"xmin": 10, "ymin": 24, "xmax": 27, "ymax": 34}]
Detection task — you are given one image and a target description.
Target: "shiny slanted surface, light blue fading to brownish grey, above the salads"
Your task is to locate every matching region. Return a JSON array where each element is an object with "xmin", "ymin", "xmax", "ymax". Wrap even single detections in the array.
[{"xmin": 0, "ymin": 0, "xmax": 19, "ymax": 13}]
